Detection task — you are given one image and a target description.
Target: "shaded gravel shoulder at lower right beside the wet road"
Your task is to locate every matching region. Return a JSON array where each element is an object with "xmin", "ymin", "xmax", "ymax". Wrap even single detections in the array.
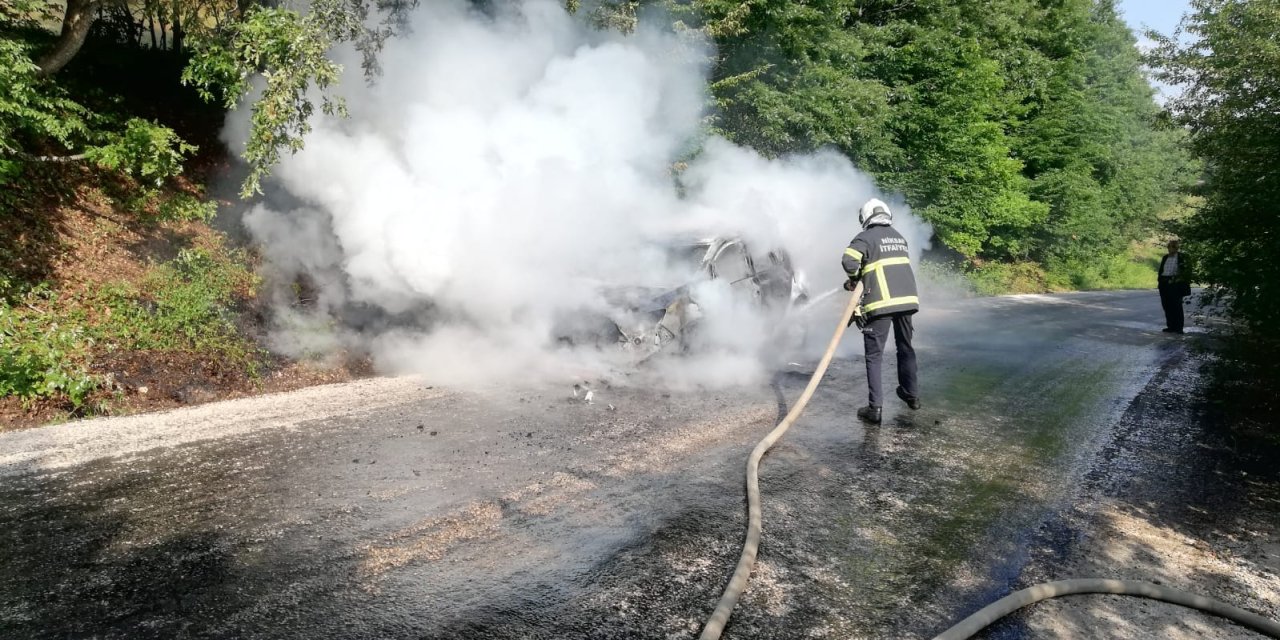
[{"xmin": 988, "ymin": 349, "xmax": 1280, "ymax": 640}]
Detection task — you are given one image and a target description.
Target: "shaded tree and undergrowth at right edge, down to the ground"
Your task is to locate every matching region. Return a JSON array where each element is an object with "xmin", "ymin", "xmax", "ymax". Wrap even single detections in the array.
[{"xmin": 1151, "ymin": 0, "xmax": 1280, "ymax": 447}]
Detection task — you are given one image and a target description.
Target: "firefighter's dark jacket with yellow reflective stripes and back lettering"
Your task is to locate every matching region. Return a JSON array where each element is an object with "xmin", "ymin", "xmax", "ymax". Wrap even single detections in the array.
[{"xmin": 842, "ymin": 224, "xmax": 920, "ymax": 317}]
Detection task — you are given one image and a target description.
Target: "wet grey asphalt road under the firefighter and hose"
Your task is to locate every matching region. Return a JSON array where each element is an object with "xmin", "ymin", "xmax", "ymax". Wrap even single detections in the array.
[{"xmin": 0, "ymin": 292, "xmax": 1196, "ymax": 639}]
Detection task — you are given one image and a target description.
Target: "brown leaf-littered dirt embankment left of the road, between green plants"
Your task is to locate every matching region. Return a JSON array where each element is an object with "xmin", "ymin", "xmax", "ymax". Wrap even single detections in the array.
[{"xmin": 0, "ymin": 157, "xmax": 371, "ymax": 431}]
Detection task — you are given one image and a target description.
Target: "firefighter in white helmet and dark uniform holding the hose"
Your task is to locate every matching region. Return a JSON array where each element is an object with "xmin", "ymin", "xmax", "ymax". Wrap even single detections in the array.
[{"xmin": 842, "ymin": 200, "xmax": 920, "ymax": 424}]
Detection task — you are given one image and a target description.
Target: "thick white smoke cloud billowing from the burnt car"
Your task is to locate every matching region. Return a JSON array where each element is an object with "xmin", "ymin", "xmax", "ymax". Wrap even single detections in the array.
[{"xmin": 227, "ymin": 0, "xmax": 931, "ymax": 385}]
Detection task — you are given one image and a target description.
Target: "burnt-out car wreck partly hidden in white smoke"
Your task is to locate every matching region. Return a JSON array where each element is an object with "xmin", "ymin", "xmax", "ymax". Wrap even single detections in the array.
[{"xmin": 557, "ymin": 237, "xmax": 808, "ymax": 362}]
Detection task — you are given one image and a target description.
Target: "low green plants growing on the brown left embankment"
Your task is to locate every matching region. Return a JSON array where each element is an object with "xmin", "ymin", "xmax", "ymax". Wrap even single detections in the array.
[{"xmin": 0, "ymin": 199, "xmax": 264, "ymax": 415}]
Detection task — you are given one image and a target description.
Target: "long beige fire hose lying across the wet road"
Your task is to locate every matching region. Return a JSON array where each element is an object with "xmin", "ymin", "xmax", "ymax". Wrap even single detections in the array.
[{"xmin": 699, "ymin": 291, "xmax": 1280, "ymax": 640}]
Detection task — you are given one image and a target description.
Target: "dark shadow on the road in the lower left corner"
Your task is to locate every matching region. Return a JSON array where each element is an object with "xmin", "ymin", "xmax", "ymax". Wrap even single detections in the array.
[{"xmin": 0, "ymin": 475, "xmax": 232, "ymax": 639}]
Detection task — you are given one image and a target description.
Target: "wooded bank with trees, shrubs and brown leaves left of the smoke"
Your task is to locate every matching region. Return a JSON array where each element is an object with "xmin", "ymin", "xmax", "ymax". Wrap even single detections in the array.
[{"xmin": 0, "ymin": 0, "xmax": 360, "ymax": 430}]
